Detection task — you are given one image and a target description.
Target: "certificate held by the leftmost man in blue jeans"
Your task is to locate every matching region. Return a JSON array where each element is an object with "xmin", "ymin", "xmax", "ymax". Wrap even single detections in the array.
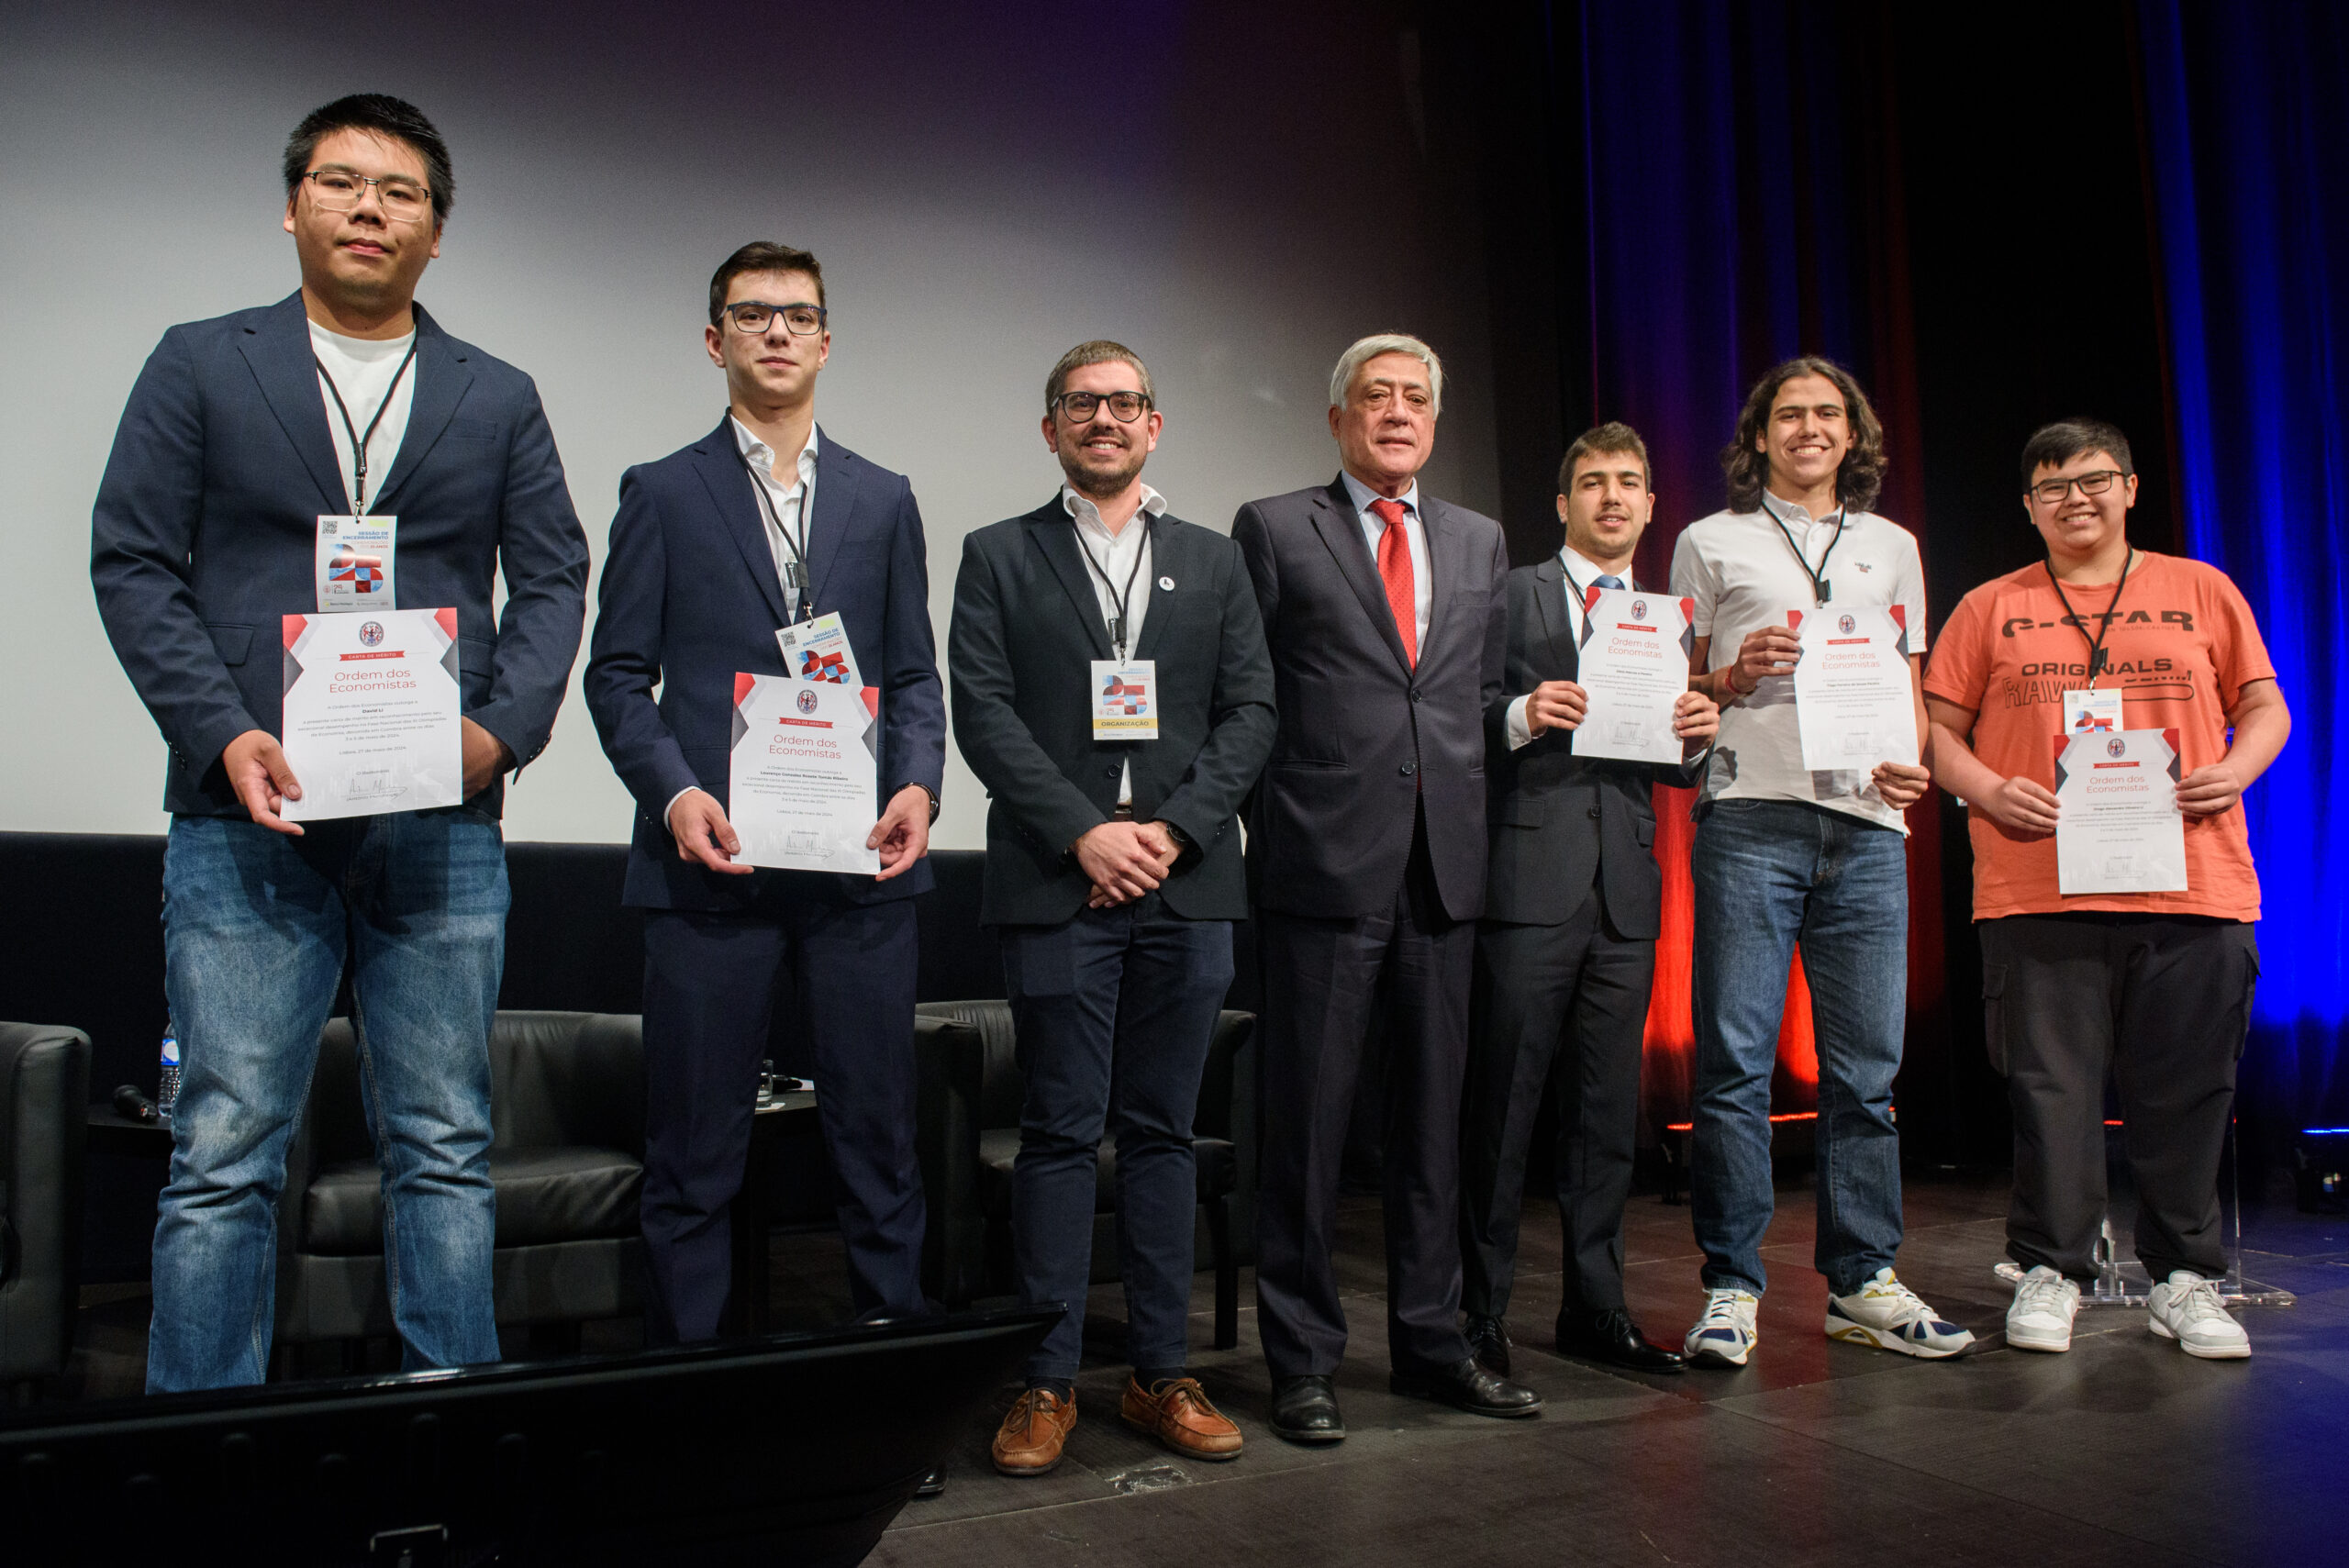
[{"xmin": 280, "ymin": 610, "xmax": 465, "ymax": 821}]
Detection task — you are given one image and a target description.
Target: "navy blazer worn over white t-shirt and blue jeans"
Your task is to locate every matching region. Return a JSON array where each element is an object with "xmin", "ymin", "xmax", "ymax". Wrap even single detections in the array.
[{"xmin": 89, "ymin": 294, "xmax": 587, "ymax": 817}]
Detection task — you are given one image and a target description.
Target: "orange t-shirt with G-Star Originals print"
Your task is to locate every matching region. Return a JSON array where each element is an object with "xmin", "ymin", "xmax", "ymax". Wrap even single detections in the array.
[{"xmin": 1924, "ymin": 550, "xmax": 2277, "ymax": 920}]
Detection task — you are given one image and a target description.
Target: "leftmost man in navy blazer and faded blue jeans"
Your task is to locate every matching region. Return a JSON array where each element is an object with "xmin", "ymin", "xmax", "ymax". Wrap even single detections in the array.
[{"xmin": 89, "ymin": 94, "xmax": 587, "ymax": 1392}]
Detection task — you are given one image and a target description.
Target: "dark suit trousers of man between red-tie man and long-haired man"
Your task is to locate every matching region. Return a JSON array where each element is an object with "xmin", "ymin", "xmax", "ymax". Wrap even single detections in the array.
[{"xmin": 1461, "ymin": 887, "xmax": 1656, "ymax": 1317}]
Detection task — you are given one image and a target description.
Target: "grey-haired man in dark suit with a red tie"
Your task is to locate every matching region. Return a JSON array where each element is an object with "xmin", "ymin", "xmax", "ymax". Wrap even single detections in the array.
[{"xmin": 1230, "ymin": 333, "xmax": 1541, "ymax": 1443}]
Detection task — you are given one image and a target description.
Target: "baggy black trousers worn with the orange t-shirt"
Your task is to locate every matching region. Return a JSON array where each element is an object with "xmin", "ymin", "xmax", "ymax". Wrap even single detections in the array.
[{"xmin": 1976, "ymin": 913, "xmax": 2260, "ymax": 1282}]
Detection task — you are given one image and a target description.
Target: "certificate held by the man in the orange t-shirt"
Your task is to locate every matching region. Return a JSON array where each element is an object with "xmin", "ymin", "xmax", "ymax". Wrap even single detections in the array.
[{"xmin": 2055, "ymin": 730, "xmax": 2187, "ymax": 895}]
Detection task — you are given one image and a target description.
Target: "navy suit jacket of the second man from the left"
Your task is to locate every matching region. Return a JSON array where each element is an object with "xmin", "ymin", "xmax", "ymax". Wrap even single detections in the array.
[{"xmin": 584, "ymin": 417, "xmax": 947, "ymax": 911}]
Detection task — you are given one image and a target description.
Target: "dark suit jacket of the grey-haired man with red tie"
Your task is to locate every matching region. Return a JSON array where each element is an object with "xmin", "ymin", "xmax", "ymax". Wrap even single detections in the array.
[{"xmin": 1230, "ymin": 479, "xmax": 1508, "ymax": 920}]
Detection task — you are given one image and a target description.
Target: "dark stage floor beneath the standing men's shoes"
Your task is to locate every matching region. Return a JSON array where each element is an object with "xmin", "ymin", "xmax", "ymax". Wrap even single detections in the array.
[{"xmin": 869, "ymin": 1173, "xmax": 2349, "ymax": 1568}]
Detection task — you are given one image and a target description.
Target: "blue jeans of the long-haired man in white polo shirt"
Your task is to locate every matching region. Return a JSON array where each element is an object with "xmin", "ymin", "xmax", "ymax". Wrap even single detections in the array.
[{"xmin": 1689, "ymin": 800, "xmax": 1908, "ymax": 1296}]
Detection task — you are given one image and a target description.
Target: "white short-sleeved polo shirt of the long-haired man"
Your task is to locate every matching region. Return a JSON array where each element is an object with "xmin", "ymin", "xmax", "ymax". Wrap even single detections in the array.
[{"xmin": 1673, "ymin": 495, "xmax": 1924, "ymax": 833}]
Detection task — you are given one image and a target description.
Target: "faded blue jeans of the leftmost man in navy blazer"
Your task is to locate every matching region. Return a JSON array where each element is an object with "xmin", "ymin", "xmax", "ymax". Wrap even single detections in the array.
[{"xmin": 148, "ymin": 806, "xmax": 507, "ymax": 1395}]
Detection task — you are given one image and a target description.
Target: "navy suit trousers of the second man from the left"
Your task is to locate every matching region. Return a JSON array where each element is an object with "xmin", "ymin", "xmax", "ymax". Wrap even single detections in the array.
[{"xmin": 643, "ymin": 873, "xmax": 928, "ymax": 1342}]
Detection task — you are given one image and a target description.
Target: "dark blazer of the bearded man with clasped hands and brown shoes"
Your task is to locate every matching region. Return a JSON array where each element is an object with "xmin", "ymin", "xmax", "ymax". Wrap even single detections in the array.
[{"xmin": 947, "ymin": 495, "xmax": 1274, "ymax": 925}]
